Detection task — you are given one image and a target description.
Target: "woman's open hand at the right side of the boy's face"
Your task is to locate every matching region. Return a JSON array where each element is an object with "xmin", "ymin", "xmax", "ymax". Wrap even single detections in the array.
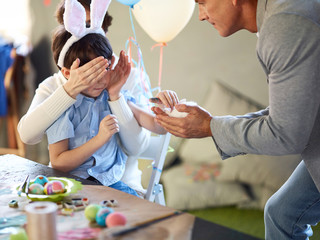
[{"xmin": 107, "ymin": 51, "xmax": 131, "ymax": 101}]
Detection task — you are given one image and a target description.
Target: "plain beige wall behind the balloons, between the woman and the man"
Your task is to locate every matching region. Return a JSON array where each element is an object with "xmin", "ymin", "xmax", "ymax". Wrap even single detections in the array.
[{"xmin": 108, "ymin": 1, "xmax": 268, "ymax": 106}]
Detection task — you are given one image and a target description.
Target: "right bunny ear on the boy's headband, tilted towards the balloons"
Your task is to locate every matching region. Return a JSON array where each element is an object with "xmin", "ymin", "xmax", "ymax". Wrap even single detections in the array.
[{"xmin": 90, "ymin": 0, "xmax": 111, "ymax": 29}]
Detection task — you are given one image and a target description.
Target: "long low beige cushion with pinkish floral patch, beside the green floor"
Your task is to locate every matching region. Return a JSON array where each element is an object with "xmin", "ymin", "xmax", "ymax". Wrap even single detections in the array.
[{"xmin": 162, "ymin": 163, "xmax": 250, "ymax": 210}]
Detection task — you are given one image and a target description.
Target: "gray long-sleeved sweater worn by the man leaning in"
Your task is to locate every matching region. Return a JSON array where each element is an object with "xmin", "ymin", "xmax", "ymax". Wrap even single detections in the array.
[{"xmin": 211, "ymin": 0, "xmax": 320, "ymax": 191}]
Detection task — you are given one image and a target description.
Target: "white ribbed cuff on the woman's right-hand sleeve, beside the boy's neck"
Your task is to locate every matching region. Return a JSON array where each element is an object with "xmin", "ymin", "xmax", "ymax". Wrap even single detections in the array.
[{"xmin": 108, "ymin": 95, "xmax": 133, "ymax": 123}]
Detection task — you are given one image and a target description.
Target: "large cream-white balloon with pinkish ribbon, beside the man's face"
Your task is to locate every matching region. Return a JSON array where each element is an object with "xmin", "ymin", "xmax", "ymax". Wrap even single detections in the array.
[{"xmin": 132, "ymin": 0, "xmax": 195, "ymax": 42}]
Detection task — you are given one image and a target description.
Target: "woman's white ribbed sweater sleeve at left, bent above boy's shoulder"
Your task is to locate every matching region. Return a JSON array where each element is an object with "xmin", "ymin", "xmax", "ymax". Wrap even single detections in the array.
[{"xmin": 18, "ymin": 78, "xmax": 75, "ymax": 144}]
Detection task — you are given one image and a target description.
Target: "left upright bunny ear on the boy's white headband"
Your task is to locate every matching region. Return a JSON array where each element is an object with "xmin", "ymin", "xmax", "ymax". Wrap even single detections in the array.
[{"xmin": 63, "ymin": 0, "xmax": 86, "ymax": 38}]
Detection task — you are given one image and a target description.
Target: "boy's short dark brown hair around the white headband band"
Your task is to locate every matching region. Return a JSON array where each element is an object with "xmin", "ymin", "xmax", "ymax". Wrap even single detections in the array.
[{"xmin": 52, "ymin": 25, "xmax": 113, "ymax": 69}]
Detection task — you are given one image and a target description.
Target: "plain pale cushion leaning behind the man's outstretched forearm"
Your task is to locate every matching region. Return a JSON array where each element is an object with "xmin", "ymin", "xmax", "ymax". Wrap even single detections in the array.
[{"xmin": 179, "ymin": 82, "xmax": 261, "ymax": 163}]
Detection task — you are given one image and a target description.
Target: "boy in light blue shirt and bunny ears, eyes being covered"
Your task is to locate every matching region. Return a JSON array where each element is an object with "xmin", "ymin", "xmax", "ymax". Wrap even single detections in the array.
[{"xmin": 47, "ymin": 1, "xmax": 179, "ymax": 195}]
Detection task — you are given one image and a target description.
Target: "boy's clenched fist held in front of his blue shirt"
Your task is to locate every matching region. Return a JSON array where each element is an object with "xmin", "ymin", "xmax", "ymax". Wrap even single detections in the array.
[{"xmin": 97, "ymin": 114, "xmax": 119, "ymax": 143}]
